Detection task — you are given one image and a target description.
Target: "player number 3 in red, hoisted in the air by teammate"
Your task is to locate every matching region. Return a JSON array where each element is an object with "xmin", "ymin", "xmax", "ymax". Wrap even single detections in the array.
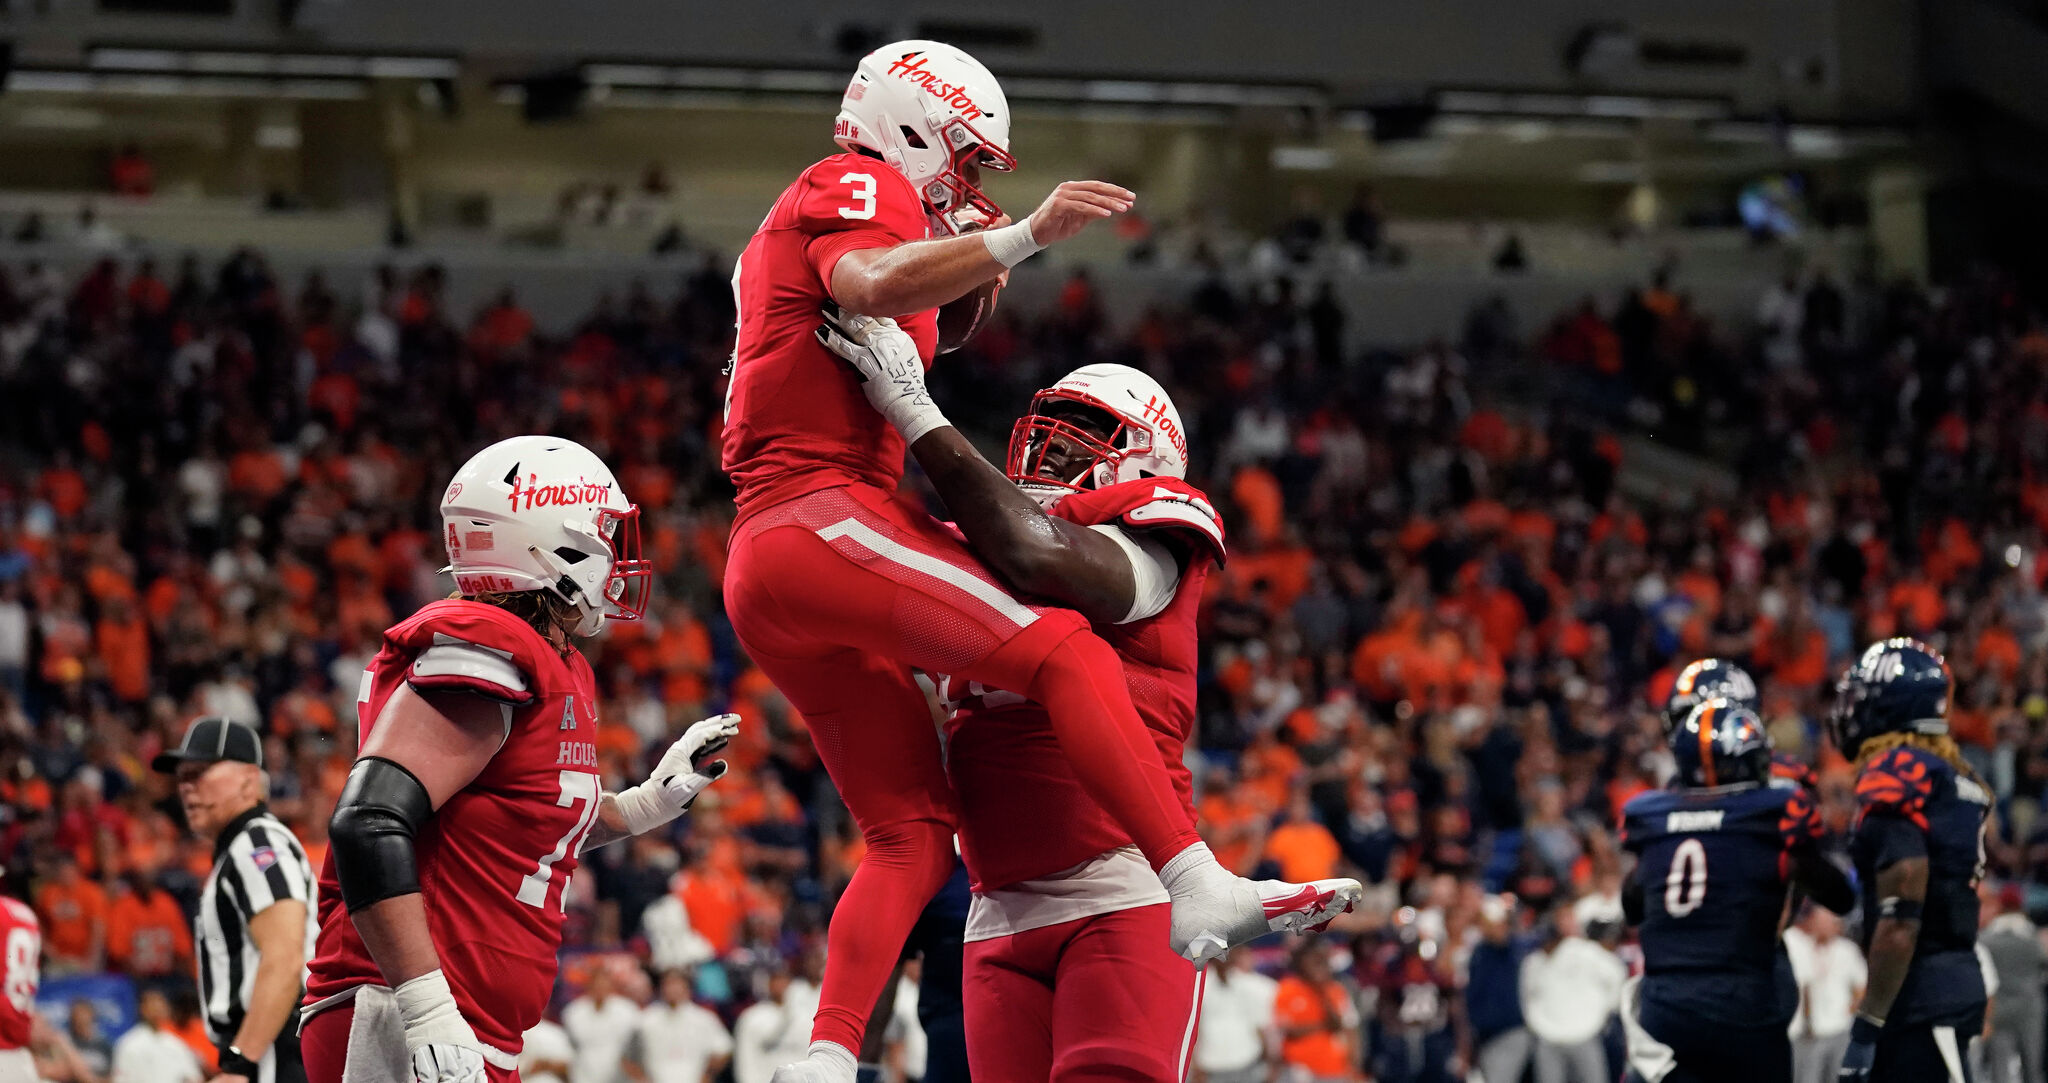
[{"xmin": 723, "ymin": 41, "xmax": 1264, "ymax": 1083}]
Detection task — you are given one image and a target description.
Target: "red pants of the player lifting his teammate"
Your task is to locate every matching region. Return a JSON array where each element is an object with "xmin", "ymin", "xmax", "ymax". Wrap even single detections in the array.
[{"xmin": 961, "ymin": 903, "xmax": 1204, "ymax": 1083}]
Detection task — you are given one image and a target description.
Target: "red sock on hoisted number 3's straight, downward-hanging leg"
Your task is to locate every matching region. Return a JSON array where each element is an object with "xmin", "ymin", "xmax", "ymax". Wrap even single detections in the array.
[{"xmin": 811, "ymin": 821, "xmax": 954, "ymax": 1056}]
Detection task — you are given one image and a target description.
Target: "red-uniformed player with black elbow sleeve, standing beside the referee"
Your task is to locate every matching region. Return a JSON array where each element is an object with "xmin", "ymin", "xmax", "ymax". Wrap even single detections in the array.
[{"xmin": 301, "ymin": 436, "xmax": 737, "ymax": 1083}]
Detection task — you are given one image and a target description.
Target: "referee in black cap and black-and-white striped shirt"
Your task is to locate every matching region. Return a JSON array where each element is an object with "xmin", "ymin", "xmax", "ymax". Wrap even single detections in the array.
[{"xmin": 152, "ymin": 717, "xmax": 317, "ymax": 1083}]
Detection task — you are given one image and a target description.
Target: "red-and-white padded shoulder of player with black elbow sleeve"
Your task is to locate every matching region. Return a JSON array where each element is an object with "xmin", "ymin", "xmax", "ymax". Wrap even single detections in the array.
[{"xmin": 385, "ymin": 600, "xmax": 551, "ymax": 704}]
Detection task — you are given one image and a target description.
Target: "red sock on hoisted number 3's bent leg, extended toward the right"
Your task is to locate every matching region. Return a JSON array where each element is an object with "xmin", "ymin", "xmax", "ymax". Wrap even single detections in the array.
[{"xmin": 1024, "ymin": 633, "xmax": 1202, "ymax": 870}]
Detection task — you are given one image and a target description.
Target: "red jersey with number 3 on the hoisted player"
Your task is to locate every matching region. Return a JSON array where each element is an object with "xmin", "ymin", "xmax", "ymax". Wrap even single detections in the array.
[{"xmin": 725, "ymin": 154, "xmax": 938, "ymax": 518}]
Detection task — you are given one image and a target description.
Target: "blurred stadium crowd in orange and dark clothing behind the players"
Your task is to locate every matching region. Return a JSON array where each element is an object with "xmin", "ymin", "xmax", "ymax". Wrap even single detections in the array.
[{"xmin": 0, "ymin": 240, "xmax": 2048, "ymax": 1083}]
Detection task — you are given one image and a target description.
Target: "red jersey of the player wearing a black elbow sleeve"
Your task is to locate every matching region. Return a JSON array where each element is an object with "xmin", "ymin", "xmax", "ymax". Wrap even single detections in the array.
[{"xmin": 305, "ymin": 600, "xmax": 600, "ymax": 1054}]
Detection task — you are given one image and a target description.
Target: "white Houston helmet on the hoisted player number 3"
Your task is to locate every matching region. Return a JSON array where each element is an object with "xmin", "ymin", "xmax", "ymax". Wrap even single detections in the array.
[{"xmin": 831, "ymin": 41, "xmax": 1018, "ymax": 233}]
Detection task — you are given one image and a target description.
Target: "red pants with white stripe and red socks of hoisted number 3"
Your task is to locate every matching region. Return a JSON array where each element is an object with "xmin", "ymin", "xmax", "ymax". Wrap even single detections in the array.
[{"xmin": 725, "ymin": 485, "xmax": 1200, "ymax": 1050}]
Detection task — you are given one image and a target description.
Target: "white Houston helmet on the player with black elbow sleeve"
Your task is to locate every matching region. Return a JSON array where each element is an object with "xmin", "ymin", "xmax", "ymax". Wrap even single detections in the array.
[{"xmin": 440, "ymin": 436, "xmax": 653, "ymax": 635}]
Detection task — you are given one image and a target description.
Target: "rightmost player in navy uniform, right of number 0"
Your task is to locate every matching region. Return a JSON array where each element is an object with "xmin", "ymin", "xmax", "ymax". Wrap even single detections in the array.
[{"xmin": 1829, "ymin": 639, "xmax": 1991, "ymax": 1083}]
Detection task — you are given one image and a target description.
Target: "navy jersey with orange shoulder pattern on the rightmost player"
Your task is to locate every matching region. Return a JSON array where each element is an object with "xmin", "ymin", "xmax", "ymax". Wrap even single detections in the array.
[{"xmin": 1849, "ymin": 745, "xmax": 1991, "ymax": 1024}]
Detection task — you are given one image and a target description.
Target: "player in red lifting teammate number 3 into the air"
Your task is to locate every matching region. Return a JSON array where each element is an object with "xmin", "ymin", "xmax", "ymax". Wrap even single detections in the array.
[{"xmin": 819, "ymin": 313, "xmax": 1362, "ymax": 1081}]
